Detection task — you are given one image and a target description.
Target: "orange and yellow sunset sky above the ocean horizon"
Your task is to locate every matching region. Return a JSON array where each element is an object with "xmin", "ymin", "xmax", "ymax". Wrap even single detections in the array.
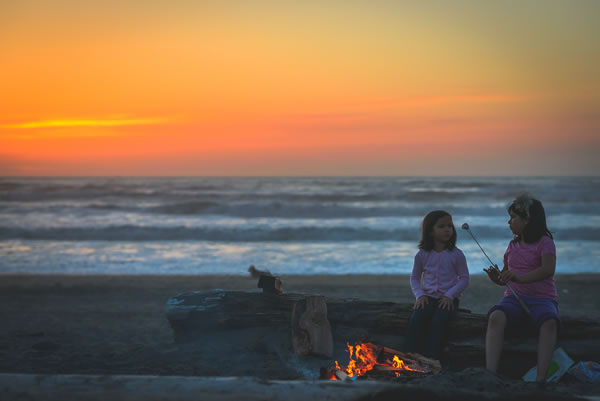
[{"xmin": 0, "ymin": 0, "xmax": 600, "ymax": 176}]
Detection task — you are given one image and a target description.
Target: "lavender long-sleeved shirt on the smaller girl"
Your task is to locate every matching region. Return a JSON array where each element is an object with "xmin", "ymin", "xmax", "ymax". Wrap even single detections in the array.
[{"xmin": 410, "ymin": 247, "xmax": 469, "ymax": 299}]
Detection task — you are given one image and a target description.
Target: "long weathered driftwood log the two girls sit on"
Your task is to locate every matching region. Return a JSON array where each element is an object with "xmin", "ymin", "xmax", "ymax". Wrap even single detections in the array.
[{"xmin": 166, "ymin": 290, "xmax": 600, "ymax": 377}]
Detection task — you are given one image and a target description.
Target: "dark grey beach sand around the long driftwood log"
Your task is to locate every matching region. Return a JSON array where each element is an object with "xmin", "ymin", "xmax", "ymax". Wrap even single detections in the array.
[{"xmin": 0, "ymin": 274, "xmax": 600, "ymax": 395}]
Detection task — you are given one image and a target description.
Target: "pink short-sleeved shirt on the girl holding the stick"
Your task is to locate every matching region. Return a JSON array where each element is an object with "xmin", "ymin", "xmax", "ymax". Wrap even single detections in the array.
[{"xmin": 504, "ymin": 235, "xmax": 557, "ymax": 300}]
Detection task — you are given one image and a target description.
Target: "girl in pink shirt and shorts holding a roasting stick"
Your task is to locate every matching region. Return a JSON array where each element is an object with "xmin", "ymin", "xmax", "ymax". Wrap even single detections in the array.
[{"xmin": 484, "ymin": 195, "xmax": 560, "ymax": 382}]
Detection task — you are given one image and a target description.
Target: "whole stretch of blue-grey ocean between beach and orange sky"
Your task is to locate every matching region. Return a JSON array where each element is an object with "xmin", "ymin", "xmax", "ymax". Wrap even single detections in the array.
[{"xmin": 0, "ymin": 177, "xmax": 600, "ymax": 275}]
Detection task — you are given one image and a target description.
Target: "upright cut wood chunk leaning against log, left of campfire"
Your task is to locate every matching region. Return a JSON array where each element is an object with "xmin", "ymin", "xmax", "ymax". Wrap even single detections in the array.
[{"xmin": 292, "ymin": 296, "xmax": 333, "ymax": 358}]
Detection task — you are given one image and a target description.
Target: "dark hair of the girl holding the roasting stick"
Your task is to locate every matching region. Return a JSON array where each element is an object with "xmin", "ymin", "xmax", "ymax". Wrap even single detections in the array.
[{"xmin": 508, "ymin": 194, "xmax": 552, "ymax": 244}]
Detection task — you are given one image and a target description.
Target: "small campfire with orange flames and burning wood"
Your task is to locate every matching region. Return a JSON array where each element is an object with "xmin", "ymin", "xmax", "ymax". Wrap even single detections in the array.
[{"xmin": 321, "ymin": 342, "xmax": 441, "ymax": 380}]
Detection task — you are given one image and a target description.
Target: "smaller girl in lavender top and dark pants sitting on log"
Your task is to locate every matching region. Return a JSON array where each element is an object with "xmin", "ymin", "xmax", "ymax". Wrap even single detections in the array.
[{"xmin": 404, "ymin": 210, "xmax": 469, "ymax": 359}]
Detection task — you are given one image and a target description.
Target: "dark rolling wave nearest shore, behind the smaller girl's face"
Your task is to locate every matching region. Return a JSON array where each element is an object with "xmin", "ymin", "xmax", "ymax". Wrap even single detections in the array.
[{"xmin": 0, "ymin": 225, "xmax": 600, "ymax": 242}]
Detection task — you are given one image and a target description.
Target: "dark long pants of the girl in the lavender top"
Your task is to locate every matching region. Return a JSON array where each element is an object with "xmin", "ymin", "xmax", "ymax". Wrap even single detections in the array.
[{"xmin": 404, "ymin": 297, "xmax": 458, "ymax": 359}]
